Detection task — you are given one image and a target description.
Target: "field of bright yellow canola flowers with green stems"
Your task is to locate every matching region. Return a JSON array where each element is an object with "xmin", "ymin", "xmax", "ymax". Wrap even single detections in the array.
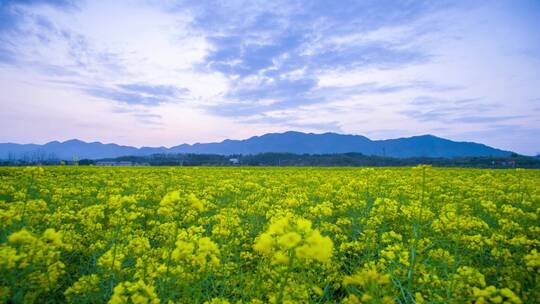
[{"xmin": 0, "ymin": 166, "xmax": 540, "ymax": 304}]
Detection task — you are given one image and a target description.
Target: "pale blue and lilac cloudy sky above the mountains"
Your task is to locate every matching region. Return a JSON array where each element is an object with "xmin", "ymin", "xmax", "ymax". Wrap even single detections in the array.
[{"xmin": 0, "ymin": 0, "xmax": 540, "ymax": 155}]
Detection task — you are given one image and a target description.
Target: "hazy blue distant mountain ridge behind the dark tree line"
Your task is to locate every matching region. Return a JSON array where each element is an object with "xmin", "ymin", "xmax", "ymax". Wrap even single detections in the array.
[{"xmin": 0, "ymin": 131, "xmax": 512, "ymax": 159}]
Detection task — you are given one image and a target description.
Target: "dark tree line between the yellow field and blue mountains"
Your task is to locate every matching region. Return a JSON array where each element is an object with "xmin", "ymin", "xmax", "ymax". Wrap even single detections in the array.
[{"xmin": 0, "ymin": 153, "xmax": 540, "ymax": 168}]
